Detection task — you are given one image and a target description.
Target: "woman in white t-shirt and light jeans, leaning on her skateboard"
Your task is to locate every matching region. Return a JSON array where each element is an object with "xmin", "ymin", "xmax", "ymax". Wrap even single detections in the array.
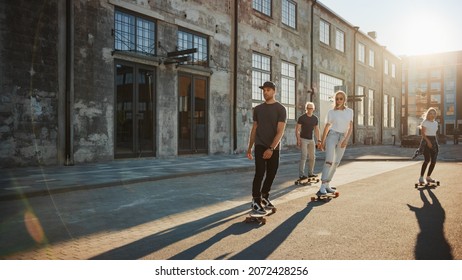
[{"xmin": 318, "ymin": 91, "xmax": 353, "ymax": 195}]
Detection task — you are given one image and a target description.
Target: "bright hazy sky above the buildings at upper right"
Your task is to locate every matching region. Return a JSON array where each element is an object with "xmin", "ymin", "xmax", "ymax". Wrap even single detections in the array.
[{"xmin": 319, "ymin": 0, "xmax": 462, "ymax": 56}]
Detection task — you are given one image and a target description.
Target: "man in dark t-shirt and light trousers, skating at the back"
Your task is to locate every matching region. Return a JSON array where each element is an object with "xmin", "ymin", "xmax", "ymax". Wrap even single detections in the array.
[{"xmin": 295, "ymin": 102, "xmax": 321, "ymax": 180}]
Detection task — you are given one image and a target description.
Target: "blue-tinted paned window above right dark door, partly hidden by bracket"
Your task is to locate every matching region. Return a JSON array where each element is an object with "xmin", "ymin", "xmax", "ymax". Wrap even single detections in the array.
[{"xmin": 177, "ymin": 30, "xmax": 209, "ymax": 66}]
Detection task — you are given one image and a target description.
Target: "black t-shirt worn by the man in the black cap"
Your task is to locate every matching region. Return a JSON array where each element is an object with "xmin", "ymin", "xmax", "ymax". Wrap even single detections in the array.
[{"xmin": 253, "ymin": 102, "xmax": 287, "ymax": 150}]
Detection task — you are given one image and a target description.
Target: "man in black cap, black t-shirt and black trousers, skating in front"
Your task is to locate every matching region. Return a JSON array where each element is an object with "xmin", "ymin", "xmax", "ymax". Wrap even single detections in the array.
[{"xmin": 247, "ymin": 82, "xmax": 287, "ymax": 214}]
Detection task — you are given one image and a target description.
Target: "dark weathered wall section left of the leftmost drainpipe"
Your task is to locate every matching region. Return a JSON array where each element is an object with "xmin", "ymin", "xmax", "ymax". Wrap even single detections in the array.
[{"xmin": 0, "ymin": 0, "xmax": 59, "ymax": 167}]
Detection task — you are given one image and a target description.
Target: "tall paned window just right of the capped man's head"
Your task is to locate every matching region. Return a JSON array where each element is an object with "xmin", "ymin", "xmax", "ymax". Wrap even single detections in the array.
[{"xmin": 281, "ymin": 62, "xmax": 296, "ymax": 119}]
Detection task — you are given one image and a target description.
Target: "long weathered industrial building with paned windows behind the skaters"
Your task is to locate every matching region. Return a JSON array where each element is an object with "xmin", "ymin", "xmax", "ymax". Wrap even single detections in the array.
[{"xmin": 0, "ymin": 0, "xmax": 402, "ymax": 167}]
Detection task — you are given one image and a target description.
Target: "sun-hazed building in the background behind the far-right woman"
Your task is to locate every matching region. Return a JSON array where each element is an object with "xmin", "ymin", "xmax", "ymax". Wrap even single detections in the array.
[{"xmin": 402, "ymin": 51, "xmax": 462, "ymax": 136}]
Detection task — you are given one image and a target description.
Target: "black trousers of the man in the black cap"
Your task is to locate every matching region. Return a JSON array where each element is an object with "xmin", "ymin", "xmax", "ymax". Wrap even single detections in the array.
[{"xmin": 252, "ymin": 145, "xmax": 279, "ymax": 198}]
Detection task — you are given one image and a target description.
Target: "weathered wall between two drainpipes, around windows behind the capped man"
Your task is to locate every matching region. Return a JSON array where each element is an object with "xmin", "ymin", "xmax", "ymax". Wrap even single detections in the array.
[{"xmin": 236, "ymin": 1, "xmax": 310, "ymax": 152}]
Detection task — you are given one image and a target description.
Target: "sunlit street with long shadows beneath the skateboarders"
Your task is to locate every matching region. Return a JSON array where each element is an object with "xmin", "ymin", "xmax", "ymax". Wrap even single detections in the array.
[{"xmin": 0, "ymin": 161, "xmax": 462, "ymax": 260}]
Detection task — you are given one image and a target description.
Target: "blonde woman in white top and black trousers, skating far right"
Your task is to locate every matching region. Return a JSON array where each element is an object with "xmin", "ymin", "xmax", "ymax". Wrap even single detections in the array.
[{"xmin": 419, "ymin": 107, "xmax": 438, "ymax": 184}]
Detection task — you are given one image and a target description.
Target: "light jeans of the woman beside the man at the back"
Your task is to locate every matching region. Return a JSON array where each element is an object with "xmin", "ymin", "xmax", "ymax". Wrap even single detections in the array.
[{"xmin": 321, "ymin": 130, "xmax": 345, "ymax": 183}]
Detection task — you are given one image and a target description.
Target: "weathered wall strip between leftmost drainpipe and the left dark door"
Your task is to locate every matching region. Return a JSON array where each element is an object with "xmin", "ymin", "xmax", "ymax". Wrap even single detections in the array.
[{"xmin": 72, "ymin": 0, "xmax": 114, "ymax": 163}]
